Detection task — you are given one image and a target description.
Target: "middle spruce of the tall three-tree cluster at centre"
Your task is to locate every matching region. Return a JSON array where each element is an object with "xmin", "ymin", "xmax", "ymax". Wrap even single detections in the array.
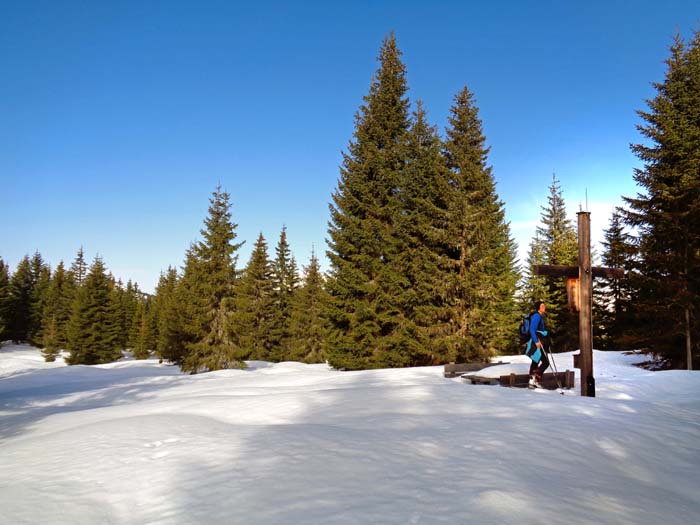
[{"xmin": 382, "ymin": 101, "xmax": 455, "ymax": 366}]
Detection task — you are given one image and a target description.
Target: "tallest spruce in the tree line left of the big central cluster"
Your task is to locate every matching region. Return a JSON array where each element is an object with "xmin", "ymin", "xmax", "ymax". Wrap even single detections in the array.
[{"xmin": 182, "ymin": 186, "xmax": 245, "ymax": 373}]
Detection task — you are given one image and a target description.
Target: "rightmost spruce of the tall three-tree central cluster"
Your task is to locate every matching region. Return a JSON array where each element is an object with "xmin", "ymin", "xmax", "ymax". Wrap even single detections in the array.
[{"xmin": 444, "ymin": 87, "xmax": 518, "ymax": 360}]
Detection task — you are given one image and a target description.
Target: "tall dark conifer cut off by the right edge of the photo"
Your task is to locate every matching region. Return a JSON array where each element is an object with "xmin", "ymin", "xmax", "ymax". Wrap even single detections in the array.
[{"xmin": 625, "ymin": 31, "xmax": 700, "ymax": 369}]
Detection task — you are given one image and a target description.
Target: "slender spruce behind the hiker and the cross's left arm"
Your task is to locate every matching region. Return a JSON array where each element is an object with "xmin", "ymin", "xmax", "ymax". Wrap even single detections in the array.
[{"xmin": 522, "ymin": 175, "xmax": 578, "ymax": 351}]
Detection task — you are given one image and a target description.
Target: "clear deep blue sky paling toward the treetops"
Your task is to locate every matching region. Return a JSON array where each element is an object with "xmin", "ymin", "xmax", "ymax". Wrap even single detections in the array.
[{"xmin": 0, "ymin": 0, "xmax": 700, "ymax": 291}]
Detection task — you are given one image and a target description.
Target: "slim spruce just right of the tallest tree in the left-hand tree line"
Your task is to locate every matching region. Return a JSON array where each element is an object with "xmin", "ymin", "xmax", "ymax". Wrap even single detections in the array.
[{"xmin": 230, "ymin": 233, "xmax": 274, "ymax": 360}]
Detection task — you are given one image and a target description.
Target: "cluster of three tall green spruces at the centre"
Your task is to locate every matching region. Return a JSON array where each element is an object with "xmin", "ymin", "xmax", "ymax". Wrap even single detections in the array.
[{"xmin": 326, "ymin": 34, "xmax": 518, "ymax": 369}]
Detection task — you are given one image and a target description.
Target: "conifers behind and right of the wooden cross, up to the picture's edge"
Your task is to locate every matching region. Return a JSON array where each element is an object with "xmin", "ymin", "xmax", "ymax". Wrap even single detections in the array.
[{"xmin": 522, "ymin": 31, "xmax": 700, "ymax": 369}]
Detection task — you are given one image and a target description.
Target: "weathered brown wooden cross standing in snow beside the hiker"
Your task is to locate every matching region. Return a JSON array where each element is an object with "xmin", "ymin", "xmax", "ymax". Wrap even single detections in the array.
[{"xmin": 534, "ymin": 211, "xmax": 623, "ymax": 397}]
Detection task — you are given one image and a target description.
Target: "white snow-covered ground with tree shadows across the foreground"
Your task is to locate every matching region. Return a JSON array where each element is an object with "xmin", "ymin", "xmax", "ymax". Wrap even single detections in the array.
[{"xmin": 0, "ymin": 345, "xmax": 700, "ymax": 525}]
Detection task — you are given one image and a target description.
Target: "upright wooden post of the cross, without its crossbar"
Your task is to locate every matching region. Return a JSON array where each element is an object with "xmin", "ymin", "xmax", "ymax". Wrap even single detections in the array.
[{"xmin": 576, "ymin": 211, "xmax": 595, "ymax": 397}]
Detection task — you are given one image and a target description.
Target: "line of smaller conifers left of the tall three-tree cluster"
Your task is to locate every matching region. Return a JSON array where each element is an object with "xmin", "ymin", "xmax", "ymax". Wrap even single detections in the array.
[{"xmin": 0, "ymin": 205, "xmax": 326, "ymax": 373}]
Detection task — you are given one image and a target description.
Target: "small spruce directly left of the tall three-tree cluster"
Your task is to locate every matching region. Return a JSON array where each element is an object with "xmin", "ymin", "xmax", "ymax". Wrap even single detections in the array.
[{"xmin": 289, "ymin": 252, "xmax": 328, "ymax": 363}]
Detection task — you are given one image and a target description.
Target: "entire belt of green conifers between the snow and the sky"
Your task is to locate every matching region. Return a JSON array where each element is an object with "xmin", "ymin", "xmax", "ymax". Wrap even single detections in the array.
[{"xmin": 0, "ymin": 32, "xmax": 700, "ymax": 373}]
